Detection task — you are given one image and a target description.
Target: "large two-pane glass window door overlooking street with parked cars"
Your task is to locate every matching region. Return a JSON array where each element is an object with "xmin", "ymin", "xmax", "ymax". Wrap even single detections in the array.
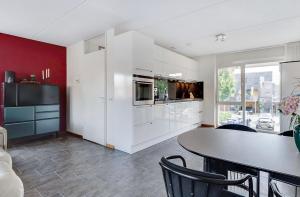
[{"xmin": 217, "ymin": 63, "xmax": 280, "ymax": 132}]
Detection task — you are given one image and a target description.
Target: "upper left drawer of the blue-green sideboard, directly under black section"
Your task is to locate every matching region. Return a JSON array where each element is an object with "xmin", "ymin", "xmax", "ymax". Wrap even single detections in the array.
[{"xmin": 4, "ymin": 106, "xmax": 34, "ymax": 123}]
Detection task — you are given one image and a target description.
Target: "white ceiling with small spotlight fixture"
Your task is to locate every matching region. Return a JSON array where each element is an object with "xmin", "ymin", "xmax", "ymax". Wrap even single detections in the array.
[{"xmin": 0, "ymin": 0, "xmax": 300, "ymax": 57}]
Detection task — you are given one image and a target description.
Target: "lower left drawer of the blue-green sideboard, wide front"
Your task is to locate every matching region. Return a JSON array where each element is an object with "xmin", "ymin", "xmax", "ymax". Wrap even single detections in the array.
[{"xmin": 4, "ymin": 121, "xmax": 34, "ymax": 139}]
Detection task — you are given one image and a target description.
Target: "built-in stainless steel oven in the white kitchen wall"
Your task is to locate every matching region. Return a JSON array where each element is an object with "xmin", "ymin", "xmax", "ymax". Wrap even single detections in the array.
[{"xmin": 133, "ymin": 75, "xmax": 154, "ymax": 105}]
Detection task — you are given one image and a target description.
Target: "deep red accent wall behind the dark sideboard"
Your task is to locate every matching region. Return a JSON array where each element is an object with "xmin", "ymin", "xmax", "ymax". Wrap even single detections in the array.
[{"xmin": 0, "ymin": 33, "xmax": 67, "ymax": 131}]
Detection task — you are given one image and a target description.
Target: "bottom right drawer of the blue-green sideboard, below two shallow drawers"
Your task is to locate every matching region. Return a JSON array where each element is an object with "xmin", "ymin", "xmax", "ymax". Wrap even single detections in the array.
[{"xmin": 35, "ymin": 118, "xmax": 59, "ymax": 134}]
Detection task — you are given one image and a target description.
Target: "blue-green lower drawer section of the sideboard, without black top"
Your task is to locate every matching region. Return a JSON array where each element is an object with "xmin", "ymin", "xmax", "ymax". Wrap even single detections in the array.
[{"xmin": 4, "ymin": 105, "xmax": 60, "ymax": 139}]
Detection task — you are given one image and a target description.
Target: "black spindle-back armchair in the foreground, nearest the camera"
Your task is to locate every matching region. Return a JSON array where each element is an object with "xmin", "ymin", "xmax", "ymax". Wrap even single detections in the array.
[{"xmin": 159, "ymin": 155, "xmax": 253, "ymax": 197}]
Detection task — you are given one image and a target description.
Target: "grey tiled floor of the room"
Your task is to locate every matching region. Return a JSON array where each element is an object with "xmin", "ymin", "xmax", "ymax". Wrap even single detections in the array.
[{"xmin": 9, "ymin": 135, "xmax": 298, "ymax": 197}]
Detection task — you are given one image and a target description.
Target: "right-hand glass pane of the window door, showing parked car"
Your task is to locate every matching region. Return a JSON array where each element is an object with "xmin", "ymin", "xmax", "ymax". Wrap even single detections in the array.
[{"xmin": 245, "ymin": 63, "xmax": 280, "ymax": 132}]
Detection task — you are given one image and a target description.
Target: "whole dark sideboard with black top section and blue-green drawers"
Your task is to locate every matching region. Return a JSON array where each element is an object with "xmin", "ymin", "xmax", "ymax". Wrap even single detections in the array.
[{"xmin": 1, "ymin": 83, "xmax": 60, "ymax": 139}]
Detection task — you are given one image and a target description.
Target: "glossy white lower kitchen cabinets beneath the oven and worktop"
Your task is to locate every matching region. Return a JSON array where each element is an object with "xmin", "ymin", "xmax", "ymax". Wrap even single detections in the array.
[{"xmin": 132, "ymin": 101, "xmax": 202, "ymax": 152}]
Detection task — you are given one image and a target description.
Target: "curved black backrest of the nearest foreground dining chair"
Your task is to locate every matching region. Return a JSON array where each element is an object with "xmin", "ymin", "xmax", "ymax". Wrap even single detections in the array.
[{"xmin": 160, "ymin": 157, "xmax": 225, "ymax": 197}]
